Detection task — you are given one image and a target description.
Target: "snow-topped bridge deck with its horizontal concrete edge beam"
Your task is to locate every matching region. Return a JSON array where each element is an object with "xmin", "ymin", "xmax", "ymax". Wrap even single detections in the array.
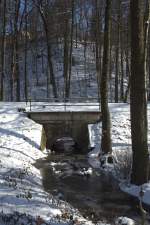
[{"xmin": 26, "ymin": 102, "xmax": 101, "ymax": 124}]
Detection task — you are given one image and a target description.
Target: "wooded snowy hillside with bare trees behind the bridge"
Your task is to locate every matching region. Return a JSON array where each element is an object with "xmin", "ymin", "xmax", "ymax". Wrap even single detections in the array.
[{"xmin": 0, "ymin": 0, "xmax": 140, "ymax": 102}]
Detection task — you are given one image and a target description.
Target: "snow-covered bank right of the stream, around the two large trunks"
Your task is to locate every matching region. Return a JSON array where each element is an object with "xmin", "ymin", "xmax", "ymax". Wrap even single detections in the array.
[{"xmin": 88, "ymin": 103, "xmax": 150, "ymax": 212}]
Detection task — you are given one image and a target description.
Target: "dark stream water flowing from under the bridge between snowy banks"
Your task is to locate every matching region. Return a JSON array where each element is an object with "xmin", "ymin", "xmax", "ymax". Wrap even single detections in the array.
[{"xmin": 36, "ymin": 154, "xmax": 146, "ymax": 224}]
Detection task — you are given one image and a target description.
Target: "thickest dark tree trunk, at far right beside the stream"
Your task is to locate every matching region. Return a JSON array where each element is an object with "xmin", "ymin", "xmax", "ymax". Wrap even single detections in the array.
[{"xmin": 130, "ymin": 0, "xmax": 149, "ymax": 185}]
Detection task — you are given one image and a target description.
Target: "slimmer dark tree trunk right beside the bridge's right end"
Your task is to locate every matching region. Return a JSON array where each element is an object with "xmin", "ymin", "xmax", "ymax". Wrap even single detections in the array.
[{"xmin": 100, "ymin": 0, "xmax": 112, "ymax": 153}]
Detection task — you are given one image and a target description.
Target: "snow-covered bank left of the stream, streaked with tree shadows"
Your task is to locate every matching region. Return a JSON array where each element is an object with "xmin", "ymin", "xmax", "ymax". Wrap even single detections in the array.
[{"xmin": 0, "ymin": 103, "xmax": 98, "ymax": 225}]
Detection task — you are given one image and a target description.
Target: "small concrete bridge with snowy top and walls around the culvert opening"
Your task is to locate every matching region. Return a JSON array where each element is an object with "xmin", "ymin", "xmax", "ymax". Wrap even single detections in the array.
[{"xmin": 27, "ymin": 103, "xmax": 101, "ymax": 151}]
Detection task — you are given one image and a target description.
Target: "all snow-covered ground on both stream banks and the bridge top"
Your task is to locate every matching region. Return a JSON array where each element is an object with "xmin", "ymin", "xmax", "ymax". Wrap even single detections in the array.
[{"xmin": 0, "ymin": 103, "xmax": 150, "ymax": 225}]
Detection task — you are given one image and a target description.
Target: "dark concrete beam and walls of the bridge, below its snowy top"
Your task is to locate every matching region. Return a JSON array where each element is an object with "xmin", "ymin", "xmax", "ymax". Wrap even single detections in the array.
[{"xmin": 28, "ymin": 111, "xmax": 101, "ymax": 152}]
